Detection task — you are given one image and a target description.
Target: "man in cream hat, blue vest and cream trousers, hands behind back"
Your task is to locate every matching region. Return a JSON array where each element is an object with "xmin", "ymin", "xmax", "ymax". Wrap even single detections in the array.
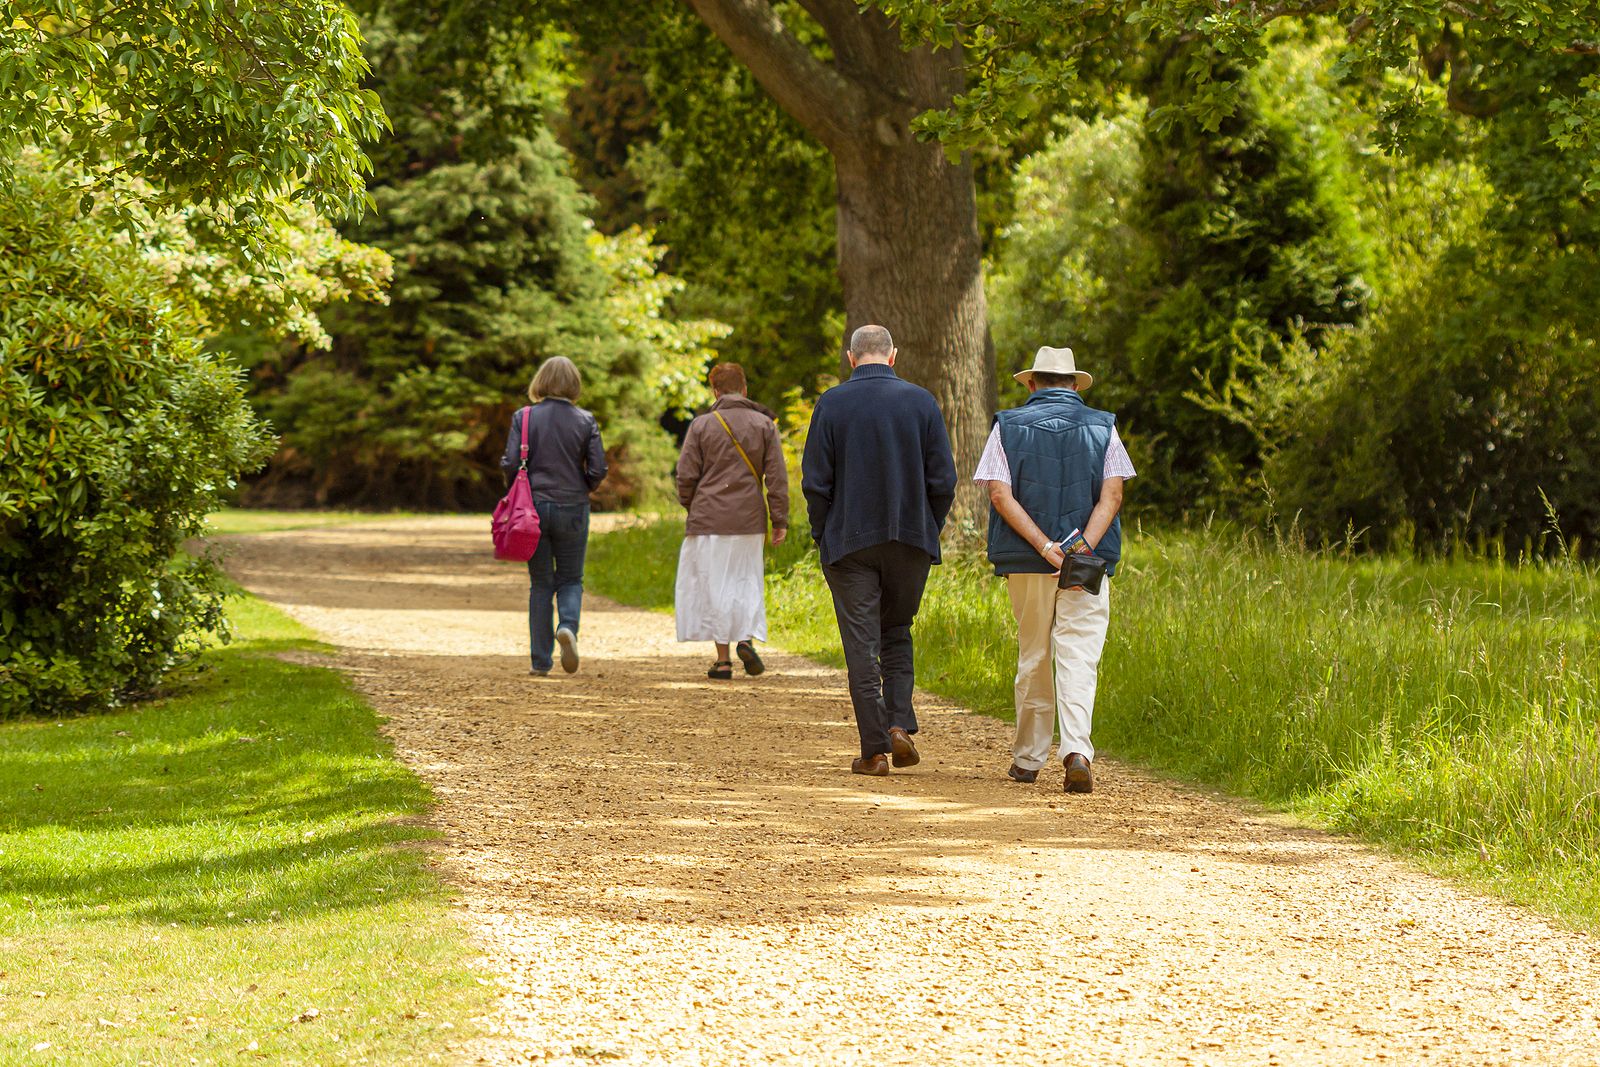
[{"xmin": 973, "ymin": 346, "xmax": 1134, "ymax": 793}]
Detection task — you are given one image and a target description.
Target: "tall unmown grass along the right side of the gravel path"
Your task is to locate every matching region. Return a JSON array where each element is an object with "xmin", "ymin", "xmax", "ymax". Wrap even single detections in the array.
[{"xmin": 587, "ymin": 523, "xmax": 1600, "ymax": 929}]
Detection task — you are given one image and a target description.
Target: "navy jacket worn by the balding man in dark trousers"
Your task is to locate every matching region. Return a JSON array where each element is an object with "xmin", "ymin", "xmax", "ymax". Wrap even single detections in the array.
[{"xmin": 800, "ymin": 363, "xmax": 955, "ymax": 565}]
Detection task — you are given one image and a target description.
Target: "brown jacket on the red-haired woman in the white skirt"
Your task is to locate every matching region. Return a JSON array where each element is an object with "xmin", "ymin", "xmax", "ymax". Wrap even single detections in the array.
[{"xmin": 678, "ymin": 394, "xmax": 789, "ymax": 536}]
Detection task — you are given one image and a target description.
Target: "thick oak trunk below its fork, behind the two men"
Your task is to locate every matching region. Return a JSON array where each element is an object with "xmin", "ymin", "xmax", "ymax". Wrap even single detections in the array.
[{"xmin": 834, "ymin": 141, "xmax": 995, "ymax": 522}]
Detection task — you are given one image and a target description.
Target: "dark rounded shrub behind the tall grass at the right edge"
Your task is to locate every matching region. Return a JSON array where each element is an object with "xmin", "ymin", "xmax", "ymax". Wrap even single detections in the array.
[{"xmin": 1264, "ymin": 242, "xmax": 1600, "ymax": 555}]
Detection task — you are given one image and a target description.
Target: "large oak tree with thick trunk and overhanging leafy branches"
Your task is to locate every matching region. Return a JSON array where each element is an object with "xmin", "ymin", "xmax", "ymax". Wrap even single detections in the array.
[{"xmin": 393, "ymin": 0, "xmax": 1600, "ymax": 489}]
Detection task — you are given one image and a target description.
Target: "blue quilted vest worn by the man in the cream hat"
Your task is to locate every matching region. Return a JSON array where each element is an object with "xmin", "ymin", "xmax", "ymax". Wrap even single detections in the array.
[{"xmin": 989, "ymin": 389, "xmax": 1122, "ymax": 574}]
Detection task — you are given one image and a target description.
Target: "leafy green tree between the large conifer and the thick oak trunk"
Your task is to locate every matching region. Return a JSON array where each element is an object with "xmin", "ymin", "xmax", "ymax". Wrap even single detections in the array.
[{"xmin": 563, "ymin": 20, "xmax": 843, "ymax": 406}]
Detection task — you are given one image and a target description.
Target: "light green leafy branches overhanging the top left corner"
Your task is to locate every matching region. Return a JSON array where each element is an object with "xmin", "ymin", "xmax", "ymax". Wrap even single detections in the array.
[{"xmin": 0, "ymin": 0, "xmax": 382, "ymax": 240}]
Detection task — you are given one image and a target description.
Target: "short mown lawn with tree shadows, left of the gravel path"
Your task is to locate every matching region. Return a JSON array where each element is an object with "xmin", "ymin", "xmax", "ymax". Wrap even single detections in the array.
[{"xmin": 0, "ymin": 598, "xmax": 488, "ymax": 1064}]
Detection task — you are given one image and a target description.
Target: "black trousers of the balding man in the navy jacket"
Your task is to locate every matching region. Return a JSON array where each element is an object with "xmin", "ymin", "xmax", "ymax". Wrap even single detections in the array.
[{"xmin": 822, "ymin": 541, "xmax": 933, "ymax": 757}]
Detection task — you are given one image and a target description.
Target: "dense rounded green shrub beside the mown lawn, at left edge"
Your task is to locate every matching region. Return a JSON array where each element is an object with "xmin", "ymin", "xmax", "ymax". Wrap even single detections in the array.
[{"xmin": 0, "ymin": 166, "xmax": 267, "ymax": 718}]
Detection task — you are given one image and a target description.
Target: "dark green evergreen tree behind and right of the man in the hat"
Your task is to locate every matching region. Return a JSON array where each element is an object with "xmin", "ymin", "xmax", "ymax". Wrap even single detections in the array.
[{"xmin": 1120, "ymin": 46, "xmax": 1366, "ymax": 509}]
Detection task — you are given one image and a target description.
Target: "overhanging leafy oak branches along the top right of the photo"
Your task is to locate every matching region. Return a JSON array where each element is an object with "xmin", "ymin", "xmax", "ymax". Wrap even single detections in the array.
[{"xmin": 883, "ymin": 0, "xmax": 1600, "ymax": 173}]
